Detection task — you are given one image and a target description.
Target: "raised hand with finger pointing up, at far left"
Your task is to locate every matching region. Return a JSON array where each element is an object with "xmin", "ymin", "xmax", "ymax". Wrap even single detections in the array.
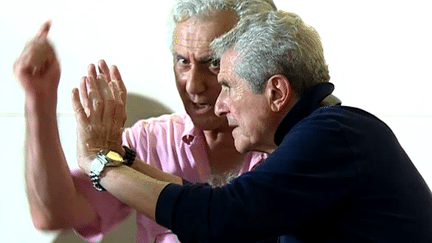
[{"xmin": 14, "ymin": 21, "xmax": 60, "ymax": 100}]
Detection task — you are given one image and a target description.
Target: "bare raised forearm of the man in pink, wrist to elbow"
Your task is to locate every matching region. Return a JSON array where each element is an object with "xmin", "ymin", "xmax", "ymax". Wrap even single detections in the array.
[{"xmin": 25, "ymin": 98, "xmax": 96, "ymax": 229}]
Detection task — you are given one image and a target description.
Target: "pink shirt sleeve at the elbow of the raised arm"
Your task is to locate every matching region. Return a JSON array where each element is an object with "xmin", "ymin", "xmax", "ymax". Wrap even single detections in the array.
[{"xmin": 72, "ymin": 169, "xmax": 132, "ymax": 242}]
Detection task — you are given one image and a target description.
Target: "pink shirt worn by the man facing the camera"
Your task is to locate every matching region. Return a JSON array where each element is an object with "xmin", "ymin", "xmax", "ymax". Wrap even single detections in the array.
[{"xmin": 73, "ymin": 113, "xmax": 267, "ymax": 243}]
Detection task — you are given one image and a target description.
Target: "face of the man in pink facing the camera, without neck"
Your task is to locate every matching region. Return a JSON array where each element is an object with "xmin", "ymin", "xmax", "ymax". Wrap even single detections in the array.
[{"xmin": 173, "ymin": 12, "xmax": 237, "ymax": 130}]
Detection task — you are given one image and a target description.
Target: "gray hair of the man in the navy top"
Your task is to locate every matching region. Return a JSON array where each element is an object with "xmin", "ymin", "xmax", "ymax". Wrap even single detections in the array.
[{"xmin": 211, "ymin": 11, "xmax": 330, "ymax": 94}]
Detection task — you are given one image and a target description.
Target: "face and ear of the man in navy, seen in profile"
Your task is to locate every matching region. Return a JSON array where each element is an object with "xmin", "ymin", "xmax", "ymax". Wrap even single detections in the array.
[{"xmin": 215, "ymin": 49, "xmax": 297, "ymax": 153}]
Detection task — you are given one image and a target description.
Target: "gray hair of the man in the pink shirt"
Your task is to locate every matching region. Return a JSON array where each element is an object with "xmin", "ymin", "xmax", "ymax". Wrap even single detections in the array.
[{"xmin": 170, "ymin": 0, "xmax": 276, "ymax": 49}]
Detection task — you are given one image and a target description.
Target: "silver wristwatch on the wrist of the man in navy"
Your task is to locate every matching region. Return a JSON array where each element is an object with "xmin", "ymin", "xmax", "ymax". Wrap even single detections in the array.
[{"xmin": 90, "ymin": 150, "xmax": 123, "ymax": 191}]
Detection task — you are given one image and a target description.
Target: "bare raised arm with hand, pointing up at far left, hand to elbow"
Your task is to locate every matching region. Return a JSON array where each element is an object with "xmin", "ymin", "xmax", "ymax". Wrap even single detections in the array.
[{"xmin": 14, "ymin": 22, "xmax": 97, "ymax": 229}]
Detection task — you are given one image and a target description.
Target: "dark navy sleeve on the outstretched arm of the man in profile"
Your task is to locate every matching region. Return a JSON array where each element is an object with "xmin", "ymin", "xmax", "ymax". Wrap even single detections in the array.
[{"xmin": 156, "ymin": 116, "xmax": 356, "ymax": 242}]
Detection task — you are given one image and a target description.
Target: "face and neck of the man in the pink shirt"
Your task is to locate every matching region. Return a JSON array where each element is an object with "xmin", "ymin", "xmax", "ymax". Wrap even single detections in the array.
[{"xmin": 173, "ymin": 11, "xmax": 244, "ymax": 174}]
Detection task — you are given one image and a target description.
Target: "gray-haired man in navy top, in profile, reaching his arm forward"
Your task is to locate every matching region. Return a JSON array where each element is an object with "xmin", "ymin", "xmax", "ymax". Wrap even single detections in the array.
[{"xmin": 69, "ymin": 8, "xmax": 432, "ymax": 243}]
